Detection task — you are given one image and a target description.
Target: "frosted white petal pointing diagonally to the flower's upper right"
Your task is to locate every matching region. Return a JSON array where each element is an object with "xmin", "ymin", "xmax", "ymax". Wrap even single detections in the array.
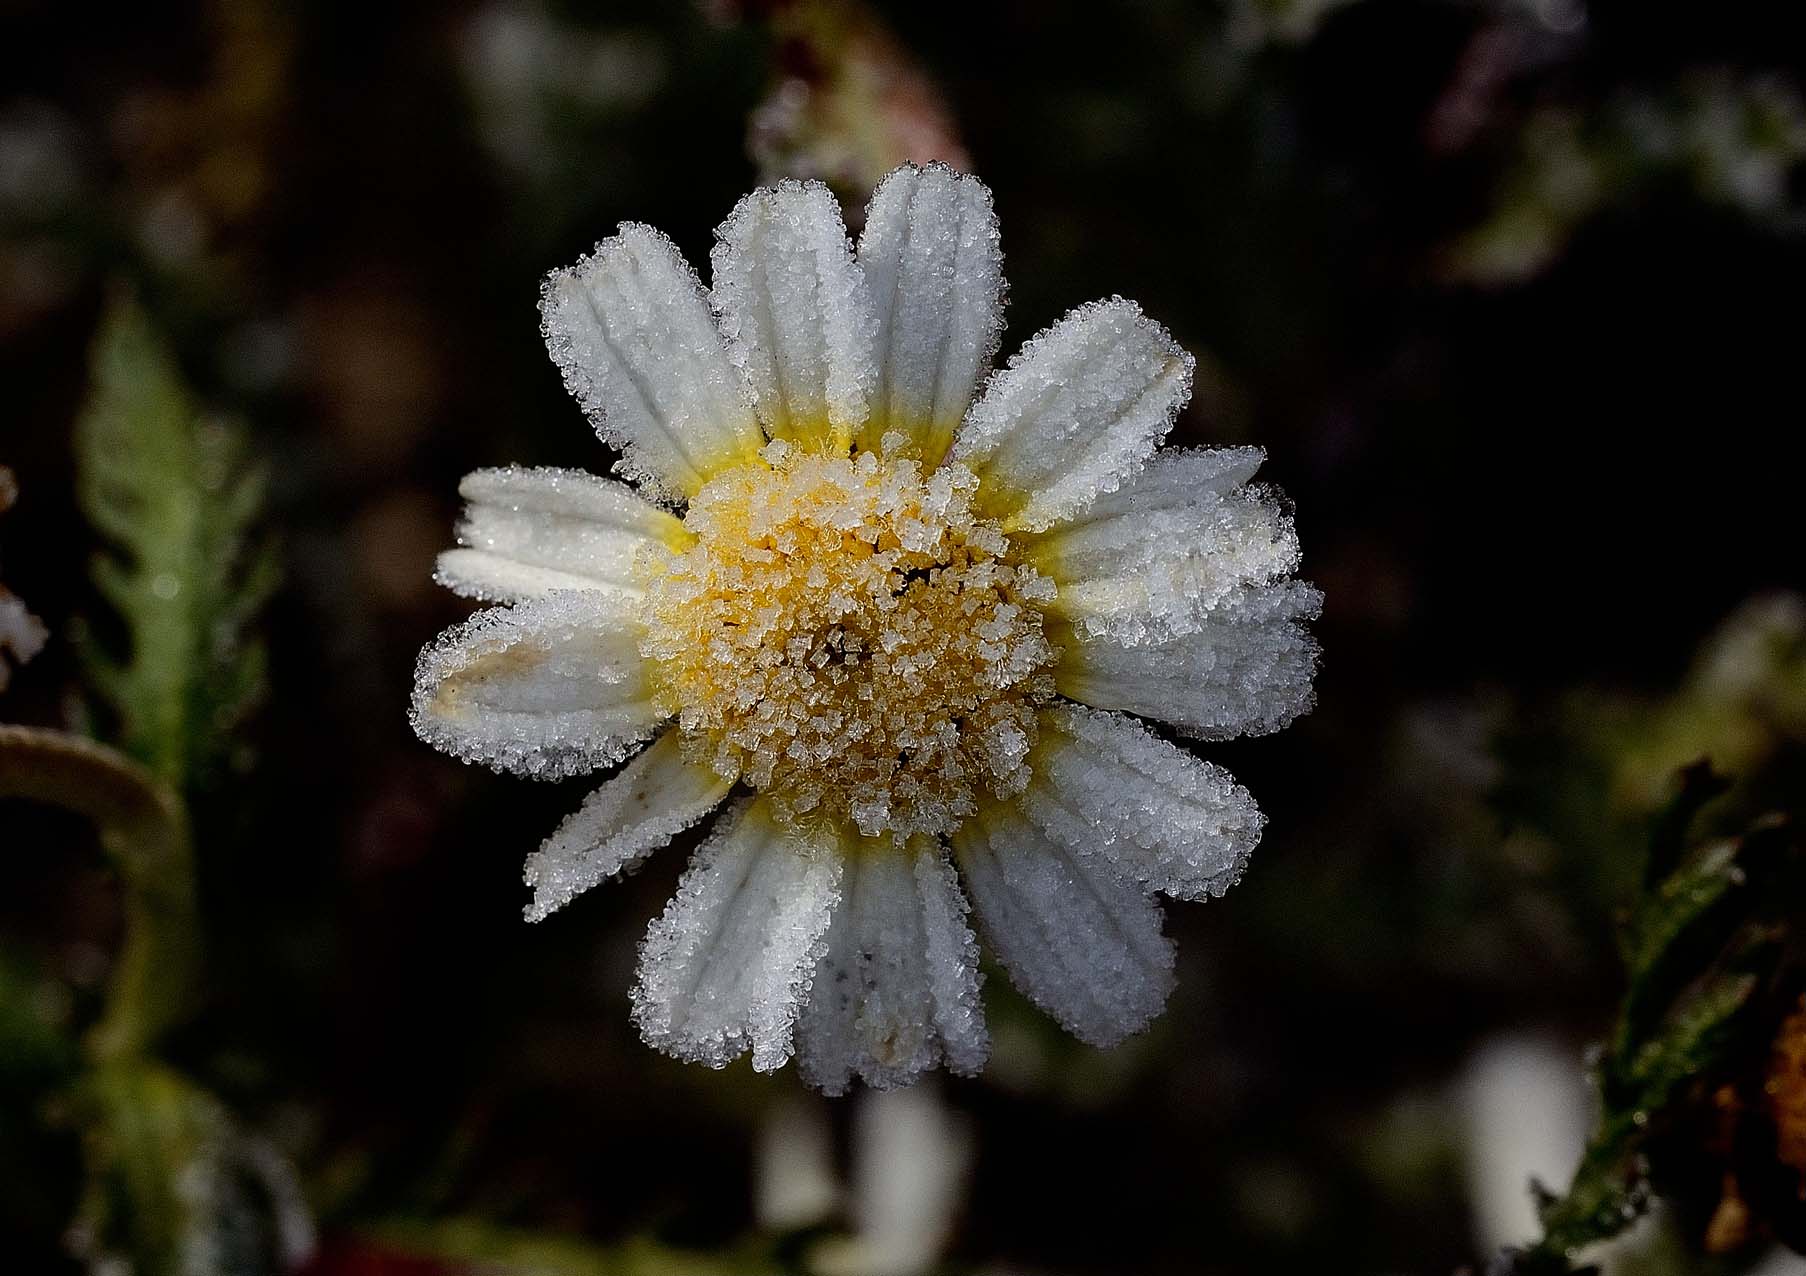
[{"xmin": 954, "ymin": 298, "xmax": 1194, "ymax": 531}]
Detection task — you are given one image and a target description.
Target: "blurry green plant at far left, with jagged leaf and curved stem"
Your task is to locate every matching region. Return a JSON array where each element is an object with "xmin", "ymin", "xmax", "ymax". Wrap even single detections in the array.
[{"xmin": 0, "ymin": 298, "xmax": 294, "ymax": 1276}]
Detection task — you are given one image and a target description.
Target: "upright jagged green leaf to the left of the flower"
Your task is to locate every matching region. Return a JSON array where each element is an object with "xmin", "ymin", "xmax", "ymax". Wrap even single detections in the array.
[{"xmin": 76, "ymin": 296, "xmax": 276, "ymax": 789}]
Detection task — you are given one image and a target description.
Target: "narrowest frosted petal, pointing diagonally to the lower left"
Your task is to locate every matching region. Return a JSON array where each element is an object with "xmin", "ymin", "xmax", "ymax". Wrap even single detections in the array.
[{"xmin": 526, "ymin": 731, "xmax": 733, "ymax": 922}]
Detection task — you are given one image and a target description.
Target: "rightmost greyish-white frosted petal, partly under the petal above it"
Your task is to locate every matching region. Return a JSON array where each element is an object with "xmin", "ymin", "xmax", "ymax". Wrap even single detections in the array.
[{"xmin": 1055, "ymin": 581, "xmax": 1324, "ymax": 740}]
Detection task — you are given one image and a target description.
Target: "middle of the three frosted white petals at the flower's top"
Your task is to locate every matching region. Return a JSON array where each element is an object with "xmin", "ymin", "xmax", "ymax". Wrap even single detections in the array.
[{"xmin": 710, "ymin": 180, "xmax": 874, "ymax": 453}]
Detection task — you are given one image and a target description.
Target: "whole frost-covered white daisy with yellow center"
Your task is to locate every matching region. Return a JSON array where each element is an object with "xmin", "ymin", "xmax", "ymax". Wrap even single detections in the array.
[{"xmin": 414, "ymin": 166, "xmax": 1320, "ymax": 1092}]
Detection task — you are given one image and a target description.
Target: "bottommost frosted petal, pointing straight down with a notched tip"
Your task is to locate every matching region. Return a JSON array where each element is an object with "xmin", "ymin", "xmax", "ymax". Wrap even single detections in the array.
[{"xmin": 796, "ymin": 837, "xmax": 990, "ymax": 1094}]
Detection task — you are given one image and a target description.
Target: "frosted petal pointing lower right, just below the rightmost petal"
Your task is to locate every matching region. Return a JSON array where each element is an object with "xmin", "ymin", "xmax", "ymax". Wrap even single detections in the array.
[{"xmin": 1019, "ymin": 704, "xmax": 1264, "ymax": 899}]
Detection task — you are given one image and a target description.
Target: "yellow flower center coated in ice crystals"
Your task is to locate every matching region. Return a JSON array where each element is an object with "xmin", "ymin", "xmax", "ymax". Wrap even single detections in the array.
[{"xmin": 643, "ymin": 442, "xmax": 1055, "ymax": 841}]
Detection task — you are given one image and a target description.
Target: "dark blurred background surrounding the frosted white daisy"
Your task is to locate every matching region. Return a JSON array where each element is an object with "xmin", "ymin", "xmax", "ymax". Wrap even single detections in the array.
[{"xmin": 0, "ymin": 0, "xmax": 1806, "ymax": 1276}]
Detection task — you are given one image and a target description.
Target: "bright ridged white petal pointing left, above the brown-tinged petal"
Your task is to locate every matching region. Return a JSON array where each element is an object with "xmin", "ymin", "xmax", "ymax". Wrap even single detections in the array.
[{"xmin": 435, "ymin": 466, "xmax": 688, "ymax": 603}]
